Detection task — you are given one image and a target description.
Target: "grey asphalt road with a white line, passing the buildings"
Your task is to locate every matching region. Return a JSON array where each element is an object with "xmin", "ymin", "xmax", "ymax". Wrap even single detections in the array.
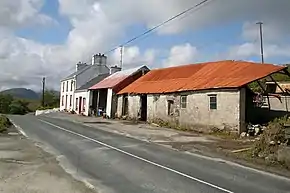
[{"xmin": 10, "ymin": 115, "xmax": 290, "ymax": 193}]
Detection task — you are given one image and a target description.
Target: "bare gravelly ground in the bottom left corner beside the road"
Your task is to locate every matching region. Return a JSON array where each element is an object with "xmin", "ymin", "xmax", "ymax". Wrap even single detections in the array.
[{"xmin": 0, "ymin": 131, "xmax": 94, "ymax": 193}]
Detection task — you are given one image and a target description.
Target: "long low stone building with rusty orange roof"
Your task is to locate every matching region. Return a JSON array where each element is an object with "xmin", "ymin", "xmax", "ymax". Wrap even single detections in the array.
[{"xmin": 117, "ymin": 61, "xmax": 286, "ymax": 132}]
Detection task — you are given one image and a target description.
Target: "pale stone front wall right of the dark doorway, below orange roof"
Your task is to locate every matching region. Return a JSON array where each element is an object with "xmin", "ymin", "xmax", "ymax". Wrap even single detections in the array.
[{"xmin": 147, "ymin": 90, "xmax": 245, "ymax": 131}]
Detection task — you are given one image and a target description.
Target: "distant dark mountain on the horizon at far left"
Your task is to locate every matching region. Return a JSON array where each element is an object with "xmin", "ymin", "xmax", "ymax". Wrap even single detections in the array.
[{"xmin": 0, "ymin": 88, "xmax": 40, "ymax": 100}]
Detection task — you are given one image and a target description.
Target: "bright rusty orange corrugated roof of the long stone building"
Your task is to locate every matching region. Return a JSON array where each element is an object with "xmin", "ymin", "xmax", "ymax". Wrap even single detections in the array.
[{"xmin": 118, "ymin": 60, "xmax": 286, "ymax": 94}]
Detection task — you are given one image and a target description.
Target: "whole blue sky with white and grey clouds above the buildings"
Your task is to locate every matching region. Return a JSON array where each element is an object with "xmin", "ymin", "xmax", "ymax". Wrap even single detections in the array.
[{"xmin": 0, "ymin": 0, "xmax": 290, "ymax": 90}]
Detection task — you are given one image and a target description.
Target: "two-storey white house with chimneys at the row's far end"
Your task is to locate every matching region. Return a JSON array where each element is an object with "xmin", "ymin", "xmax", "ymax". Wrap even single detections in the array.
[{"xmin": 60, "ymin": 54, "xmax": 110, "ymax": 111}]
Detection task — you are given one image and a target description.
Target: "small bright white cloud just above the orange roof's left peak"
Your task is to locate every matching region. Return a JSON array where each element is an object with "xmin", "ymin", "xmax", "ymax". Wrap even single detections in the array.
[{"xmin": 163, "ymin": 43, "xmax": 198, "ymax": 67}]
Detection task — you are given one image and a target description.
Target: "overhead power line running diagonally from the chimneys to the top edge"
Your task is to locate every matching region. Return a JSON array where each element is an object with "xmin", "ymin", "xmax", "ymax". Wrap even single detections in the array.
[{"xmin": 104, "ymin": 0, "xmax": 210, "ymax": 54}]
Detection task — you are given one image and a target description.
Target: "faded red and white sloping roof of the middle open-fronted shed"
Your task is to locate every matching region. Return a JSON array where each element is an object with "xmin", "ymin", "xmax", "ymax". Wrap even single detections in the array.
[{"xmin": 89, "ymin": 65, "xmax": 148, "ymax": 90}]
